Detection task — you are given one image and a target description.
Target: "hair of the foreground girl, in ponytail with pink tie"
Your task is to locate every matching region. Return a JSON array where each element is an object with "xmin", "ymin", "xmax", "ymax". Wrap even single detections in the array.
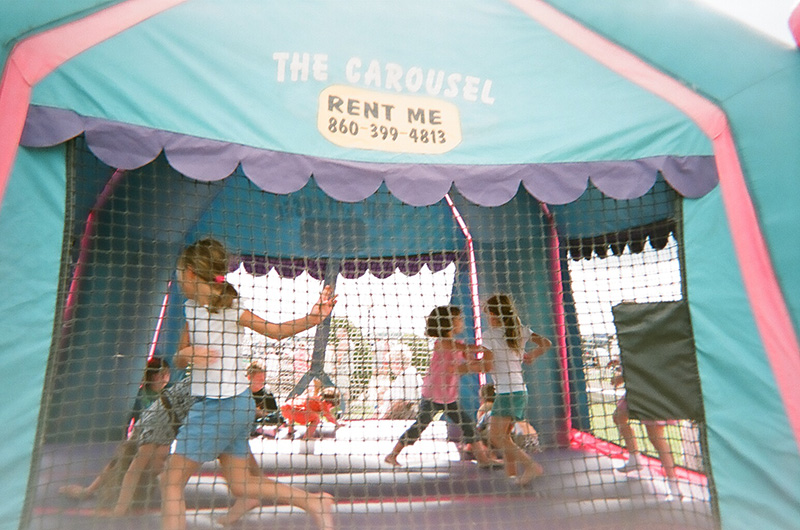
[{"xmin": 178, "ymin": 238, "xmax": 239, "ymax": 313}]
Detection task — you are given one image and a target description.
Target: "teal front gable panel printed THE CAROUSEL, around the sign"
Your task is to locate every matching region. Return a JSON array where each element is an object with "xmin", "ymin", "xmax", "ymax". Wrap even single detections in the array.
[{"xmin": 28, "ymin": 0, "xmax": 711, "ymax": 164}]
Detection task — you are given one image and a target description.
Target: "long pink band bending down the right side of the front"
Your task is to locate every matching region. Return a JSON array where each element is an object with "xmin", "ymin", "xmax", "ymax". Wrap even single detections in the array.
[{"xmin": 509, "ymin": 0, "xmax": 800, "ymax": 451}]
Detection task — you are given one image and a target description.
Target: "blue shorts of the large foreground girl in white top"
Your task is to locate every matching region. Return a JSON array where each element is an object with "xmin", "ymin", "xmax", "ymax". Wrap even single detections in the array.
[{"xmin": 173, "ymin": 390, "xmax": 256, "ymax": 462}]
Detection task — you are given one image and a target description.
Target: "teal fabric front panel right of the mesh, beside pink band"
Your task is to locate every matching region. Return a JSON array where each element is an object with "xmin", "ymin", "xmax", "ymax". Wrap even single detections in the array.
[{"xmin": 684, "ymin": 188, "xmax": 800, "ymax": 530}]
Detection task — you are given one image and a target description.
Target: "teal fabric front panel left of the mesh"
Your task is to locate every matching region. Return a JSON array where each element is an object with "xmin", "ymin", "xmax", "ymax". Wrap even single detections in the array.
[{"xmin": 0, "ymin": 146, "xmax": 65, "ymax": 529}]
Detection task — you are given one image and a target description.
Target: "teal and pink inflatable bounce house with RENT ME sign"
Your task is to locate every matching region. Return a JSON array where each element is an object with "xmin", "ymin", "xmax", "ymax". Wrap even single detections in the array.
[{"xmin": 0, "ymin": 0, "xmax": 800, "ymax": 530}]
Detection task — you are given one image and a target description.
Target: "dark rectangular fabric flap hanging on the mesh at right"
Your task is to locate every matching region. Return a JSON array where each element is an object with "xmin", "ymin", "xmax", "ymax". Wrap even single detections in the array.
[{"xmin": 611, "ymin": 302, "xmax": 703, "ymax": 421}]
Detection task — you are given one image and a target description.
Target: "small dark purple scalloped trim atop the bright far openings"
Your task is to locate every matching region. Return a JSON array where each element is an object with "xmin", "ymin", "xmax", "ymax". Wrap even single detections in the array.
[{"xmin": 230, "ymin": 252, "xmax": 464, "ymax": 280}]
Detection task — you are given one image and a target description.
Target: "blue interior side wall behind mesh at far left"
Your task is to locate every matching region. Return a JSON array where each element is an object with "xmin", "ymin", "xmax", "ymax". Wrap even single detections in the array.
[{"xmin": 44, "ymin": 151, "xmax": 221, "ymax": 441}]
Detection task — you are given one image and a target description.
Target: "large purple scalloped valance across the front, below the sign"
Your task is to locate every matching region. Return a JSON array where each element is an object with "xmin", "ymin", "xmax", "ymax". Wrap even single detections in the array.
[{"xmin": 20, "ymin": 105, "xmax": 718, "ymax": 206}]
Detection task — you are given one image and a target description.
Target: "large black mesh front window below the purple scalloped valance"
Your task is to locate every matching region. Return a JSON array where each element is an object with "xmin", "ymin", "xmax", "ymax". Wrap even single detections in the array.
[{"xmin": 23, "ymin": 138, "xmax": 717, "ymax": 529}]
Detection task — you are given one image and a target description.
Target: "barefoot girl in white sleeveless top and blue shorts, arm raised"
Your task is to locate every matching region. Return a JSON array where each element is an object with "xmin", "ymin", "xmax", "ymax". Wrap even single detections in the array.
[{"xmin": 161, "ymin": 239, "xmax": 336, "ymax": 530}]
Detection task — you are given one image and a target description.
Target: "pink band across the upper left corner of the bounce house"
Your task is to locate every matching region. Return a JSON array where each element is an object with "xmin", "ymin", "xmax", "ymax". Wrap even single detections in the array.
[{"xmin": 0, "ymin": 0, "xmax": 186, "ymax": 206}]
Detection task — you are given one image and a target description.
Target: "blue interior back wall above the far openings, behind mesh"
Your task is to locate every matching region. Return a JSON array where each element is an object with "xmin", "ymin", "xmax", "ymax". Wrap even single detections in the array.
[{"xmin": 191, "ymin": 172, "xmax": 464, "ymax": 258}]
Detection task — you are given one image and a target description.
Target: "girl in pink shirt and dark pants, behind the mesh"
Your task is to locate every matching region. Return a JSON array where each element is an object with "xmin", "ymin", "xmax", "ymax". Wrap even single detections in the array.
[{"xmin": 385, "ymin": 306, "xmax": 501, "ymax": 467}]
